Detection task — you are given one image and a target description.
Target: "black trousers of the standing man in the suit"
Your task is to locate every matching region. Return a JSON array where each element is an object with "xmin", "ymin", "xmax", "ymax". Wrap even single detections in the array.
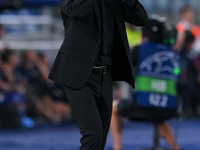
[{"xmin": 64, "ymin": 71, "xmax": 112, "ymax": 150}]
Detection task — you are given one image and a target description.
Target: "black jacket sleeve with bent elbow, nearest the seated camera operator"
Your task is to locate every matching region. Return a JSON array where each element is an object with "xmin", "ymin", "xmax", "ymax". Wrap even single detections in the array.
[{"xmin": 122, "ymin": 0, "xmax": 148, "ymax": 26}]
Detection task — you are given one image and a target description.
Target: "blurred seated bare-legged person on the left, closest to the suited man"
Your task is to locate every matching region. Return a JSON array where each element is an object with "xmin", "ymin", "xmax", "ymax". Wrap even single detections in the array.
[{"xmin": 38, "ymin": 53, "xmax": 71, "ymax": 122}]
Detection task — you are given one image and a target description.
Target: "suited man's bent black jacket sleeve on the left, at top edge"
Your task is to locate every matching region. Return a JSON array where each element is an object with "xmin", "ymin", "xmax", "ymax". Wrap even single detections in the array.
[{"xmin": 61, "ymin": 0, "xmax": 95, "ymax": 20}]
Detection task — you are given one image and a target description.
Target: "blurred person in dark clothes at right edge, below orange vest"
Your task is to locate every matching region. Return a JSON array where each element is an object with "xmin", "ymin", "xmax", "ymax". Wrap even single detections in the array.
[{"xmin": 177, "ymin": 31, "xmax": 200, "ymax": 118}]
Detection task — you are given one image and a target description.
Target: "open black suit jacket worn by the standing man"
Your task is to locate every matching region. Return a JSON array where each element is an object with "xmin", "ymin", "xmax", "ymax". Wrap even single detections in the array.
[{"xmin": 49, "ymin": 0, "xmax": 148, "ymax": 89}]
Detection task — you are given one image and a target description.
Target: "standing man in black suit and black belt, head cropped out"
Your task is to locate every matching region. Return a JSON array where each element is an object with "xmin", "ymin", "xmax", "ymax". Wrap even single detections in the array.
[{"xmin": 49, "ymin": 0, "xmax": 148, "ymax": 150}]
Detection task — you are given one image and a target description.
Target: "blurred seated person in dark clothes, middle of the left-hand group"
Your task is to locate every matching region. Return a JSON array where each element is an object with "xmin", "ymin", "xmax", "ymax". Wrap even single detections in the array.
[{"xmin": 19, "ymin": 51, "xmax": 47, "ymax": 122}]
